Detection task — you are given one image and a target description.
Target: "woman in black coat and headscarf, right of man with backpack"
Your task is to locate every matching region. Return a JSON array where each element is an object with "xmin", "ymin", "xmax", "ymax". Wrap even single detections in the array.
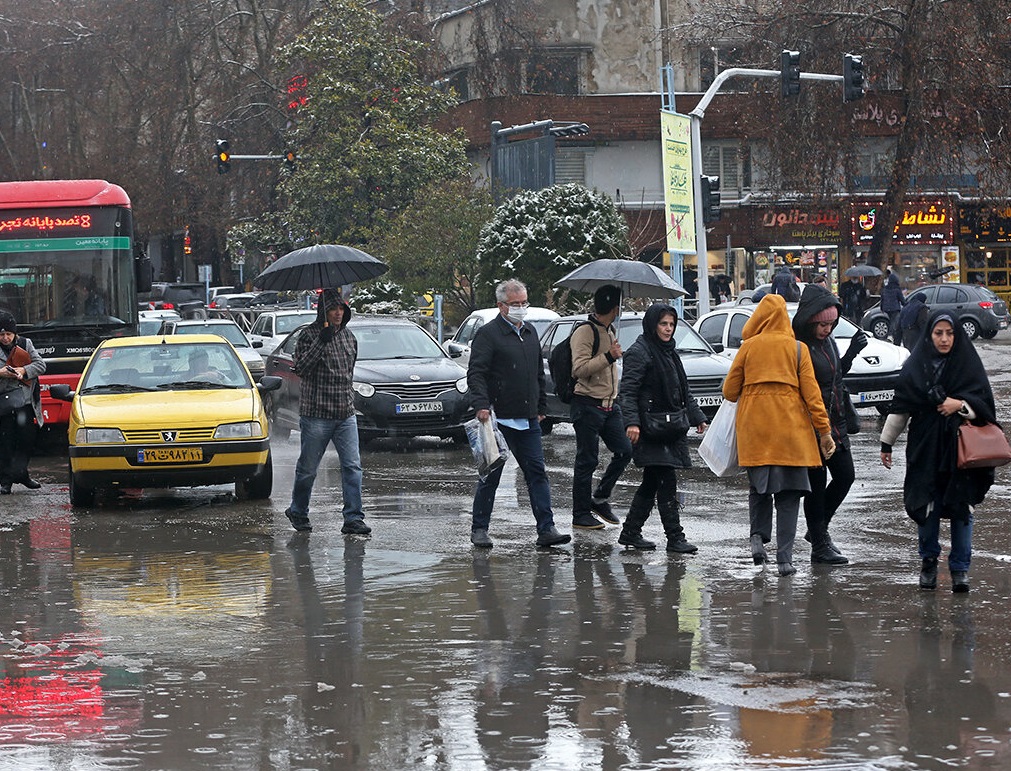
[{"xmin": 618, "ymin": 304, "xmax": 707, "ymax": 554}]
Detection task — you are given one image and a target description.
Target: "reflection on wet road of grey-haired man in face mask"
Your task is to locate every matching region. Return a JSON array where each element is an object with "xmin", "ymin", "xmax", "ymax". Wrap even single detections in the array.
[{"xmin": 473, "ymin": 551, "xmax": 563, "ymax": 768}]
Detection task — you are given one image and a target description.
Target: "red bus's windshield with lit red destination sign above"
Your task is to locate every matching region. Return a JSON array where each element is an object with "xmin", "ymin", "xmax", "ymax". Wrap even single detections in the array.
[{"xmin": 0, "ymin": 206, "xmax": 136, "ymax": 333}]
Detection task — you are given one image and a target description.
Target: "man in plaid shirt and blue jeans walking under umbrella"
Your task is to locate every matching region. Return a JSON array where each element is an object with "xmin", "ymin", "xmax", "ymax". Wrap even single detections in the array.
[{"xmin": 284, "ymin": 289, "xmax": 372, "ymax": 536}]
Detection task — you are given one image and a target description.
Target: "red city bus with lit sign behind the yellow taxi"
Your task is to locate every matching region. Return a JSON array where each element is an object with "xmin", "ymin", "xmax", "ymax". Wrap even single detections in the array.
[{"xmin": 0, "ymin": 180, "xmax": 151, "ymax": 431}]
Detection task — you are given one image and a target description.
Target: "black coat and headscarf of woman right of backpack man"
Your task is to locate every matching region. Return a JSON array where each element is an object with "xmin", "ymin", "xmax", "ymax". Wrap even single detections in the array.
[{"xmin": 618, "ymin": 305, "xmax": 706, "ymax": 469}]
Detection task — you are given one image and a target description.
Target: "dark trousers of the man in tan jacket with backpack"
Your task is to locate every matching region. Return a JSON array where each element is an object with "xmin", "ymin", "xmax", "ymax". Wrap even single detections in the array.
[{"xmin": 570, "ymin": 396, "xmax": 632, "ymax": 516}]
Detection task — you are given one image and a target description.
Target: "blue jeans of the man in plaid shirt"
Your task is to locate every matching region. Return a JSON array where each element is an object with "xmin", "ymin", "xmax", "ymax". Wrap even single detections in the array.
[{"xmin": 288, "ymin": 415, "xmax": 365, "ymax": 521}]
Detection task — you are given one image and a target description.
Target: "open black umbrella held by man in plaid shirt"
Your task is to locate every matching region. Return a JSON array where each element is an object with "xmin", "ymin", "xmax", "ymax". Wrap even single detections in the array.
[{"xmin": 253, "ymin": 244, "xmax": 389, "ymax": 291}]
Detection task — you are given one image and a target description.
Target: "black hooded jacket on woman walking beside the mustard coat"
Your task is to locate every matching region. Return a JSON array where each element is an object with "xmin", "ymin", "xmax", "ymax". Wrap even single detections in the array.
[{"xmin": 793, "ymin": 284, "xmax": 860, "ymax": 449}]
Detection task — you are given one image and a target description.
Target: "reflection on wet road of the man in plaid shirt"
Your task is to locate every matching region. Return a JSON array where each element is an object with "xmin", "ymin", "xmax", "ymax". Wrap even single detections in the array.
[{"xmin": 288, "ymin": 533, "xmax": 366, "ymax": 768}]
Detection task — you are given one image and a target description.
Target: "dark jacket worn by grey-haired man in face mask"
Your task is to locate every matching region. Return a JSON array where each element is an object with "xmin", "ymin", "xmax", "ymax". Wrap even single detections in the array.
[{"xmin": 467, "ymin": 313, "xmax": 548, "ymax": 418}]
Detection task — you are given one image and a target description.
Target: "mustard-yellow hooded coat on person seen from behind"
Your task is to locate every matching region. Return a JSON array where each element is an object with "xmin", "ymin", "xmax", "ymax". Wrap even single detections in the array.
[{"xmin": 723, "ymin": 294, "xmax": 832, "ymax": 468}]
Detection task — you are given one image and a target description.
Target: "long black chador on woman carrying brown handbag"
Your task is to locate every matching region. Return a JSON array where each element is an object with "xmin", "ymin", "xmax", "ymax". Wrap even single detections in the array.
[{"xmin": 890, "ymin": 310, "xmax": 997, "ymax": 519}]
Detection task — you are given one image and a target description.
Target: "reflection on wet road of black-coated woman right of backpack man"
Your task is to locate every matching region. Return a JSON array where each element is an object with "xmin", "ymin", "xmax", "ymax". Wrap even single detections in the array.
[{"xmin": 607, "ymin": 560, "xmax": 699, "ymax": 768}]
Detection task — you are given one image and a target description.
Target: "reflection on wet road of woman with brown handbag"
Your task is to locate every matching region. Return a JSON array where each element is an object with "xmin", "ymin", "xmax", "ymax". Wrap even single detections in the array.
[{"xmin": 906, "ymin": 595, "xmax": 990, "ymax": 768}]
